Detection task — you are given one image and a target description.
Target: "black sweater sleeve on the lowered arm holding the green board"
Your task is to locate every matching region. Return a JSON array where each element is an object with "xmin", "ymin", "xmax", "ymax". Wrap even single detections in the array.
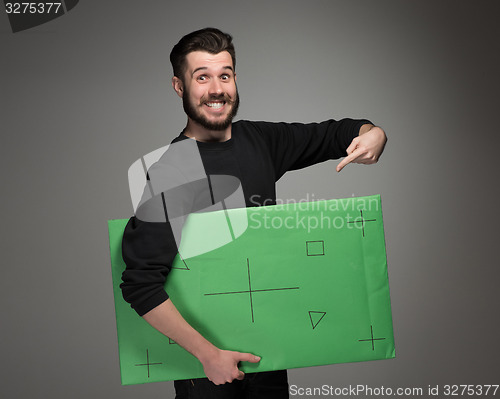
[{"xmin": 120, "ymin": 142, "xmax": 198, "ymax": 316}]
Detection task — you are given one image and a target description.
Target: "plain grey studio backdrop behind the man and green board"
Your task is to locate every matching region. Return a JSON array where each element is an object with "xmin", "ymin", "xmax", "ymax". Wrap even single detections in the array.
[{"xmin": 0, "ymin": 0, "xmax": 500, "ymax": 398}]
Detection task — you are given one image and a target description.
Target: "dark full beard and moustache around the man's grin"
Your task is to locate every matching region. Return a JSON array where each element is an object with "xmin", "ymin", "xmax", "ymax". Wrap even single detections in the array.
[{"xmin": 182, "ymin": 88, "xmax": 240, "ymax": 131}]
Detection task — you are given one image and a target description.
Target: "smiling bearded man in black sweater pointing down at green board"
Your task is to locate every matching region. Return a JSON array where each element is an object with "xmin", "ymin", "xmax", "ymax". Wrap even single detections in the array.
[{"xmin": 122, "ymin": 28, "xmax": 386, "ymax": 398}]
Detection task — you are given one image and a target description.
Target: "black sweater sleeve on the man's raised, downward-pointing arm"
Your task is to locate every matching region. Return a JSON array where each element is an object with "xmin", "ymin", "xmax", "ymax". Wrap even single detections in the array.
[{"xmin": 250, "ymin": 118, "xmax": 371, "ymax": 180}]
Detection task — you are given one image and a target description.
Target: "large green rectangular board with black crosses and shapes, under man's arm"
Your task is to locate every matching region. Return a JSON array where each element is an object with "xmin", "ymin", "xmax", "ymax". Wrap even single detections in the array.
[{"xmin": 109, "ymin": 195, "xmax": 395, "ymax": 385}]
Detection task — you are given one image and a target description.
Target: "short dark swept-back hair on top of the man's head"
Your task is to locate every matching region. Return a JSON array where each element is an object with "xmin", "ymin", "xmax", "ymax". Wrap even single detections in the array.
[{"xmin": 170, "ymin": 28, "xmax": 236, "ymax": 80}]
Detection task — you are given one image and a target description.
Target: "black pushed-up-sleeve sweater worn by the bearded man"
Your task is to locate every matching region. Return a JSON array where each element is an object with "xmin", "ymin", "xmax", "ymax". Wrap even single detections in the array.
[{"xmin": 120, "ymin": 119, "xmax": 371, "ymax": 316}]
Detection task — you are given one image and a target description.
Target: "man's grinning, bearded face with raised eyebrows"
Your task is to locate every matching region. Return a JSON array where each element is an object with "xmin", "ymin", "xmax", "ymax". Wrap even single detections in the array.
[{"xmin": 182, "ymin": 51, "xmax": 239, "ymax": 130}]
